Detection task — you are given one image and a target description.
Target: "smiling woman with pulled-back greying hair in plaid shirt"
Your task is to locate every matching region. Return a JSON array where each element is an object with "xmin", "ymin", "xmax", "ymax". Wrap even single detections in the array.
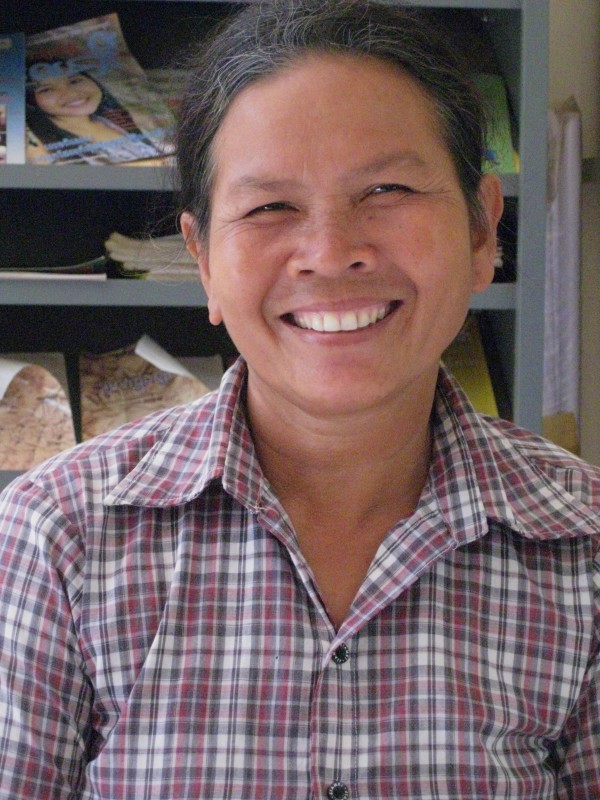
[{"xmin": 0, "ymin": 0, "xmax": 600, "ymax": 800}]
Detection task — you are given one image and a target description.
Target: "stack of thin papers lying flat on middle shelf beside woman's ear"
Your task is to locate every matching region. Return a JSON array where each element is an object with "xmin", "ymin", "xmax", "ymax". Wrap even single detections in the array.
[{"xmin": 104, "ymin": 232, "xmax": 198, "ymax": 281}]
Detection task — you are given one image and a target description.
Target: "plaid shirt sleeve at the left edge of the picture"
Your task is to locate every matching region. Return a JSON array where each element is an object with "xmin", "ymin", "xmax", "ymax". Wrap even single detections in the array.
[{"xmin": 0, "ymin": 479, "xmax": 94, "ymax": 800}]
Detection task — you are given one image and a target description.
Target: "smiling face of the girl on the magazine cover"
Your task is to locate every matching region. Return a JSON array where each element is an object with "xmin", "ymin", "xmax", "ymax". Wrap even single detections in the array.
[{"xmin": 34, "ymin": 73, "xmax": 102, "ymax": 117}]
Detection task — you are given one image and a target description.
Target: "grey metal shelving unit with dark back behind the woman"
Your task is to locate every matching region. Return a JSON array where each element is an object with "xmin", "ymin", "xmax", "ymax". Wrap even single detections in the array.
[{"xmin": 0, "ymin": 0, "xmax": 548, "ymax": 486}]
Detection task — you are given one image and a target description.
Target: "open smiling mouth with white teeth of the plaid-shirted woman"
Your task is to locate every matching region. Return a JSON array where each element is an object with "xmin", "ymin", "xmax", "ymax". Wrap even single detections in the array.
[{"xmin": 281, "ymin": 300, "xmax": 402, "ymax": 336}]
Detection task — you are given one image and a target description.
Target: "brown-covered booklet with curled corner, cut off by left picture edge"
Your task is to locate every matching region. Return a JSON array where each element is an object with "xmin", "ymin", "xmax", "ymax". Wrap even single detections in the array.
[{"xmin": 0, "ymin": 353, "xmax": 75, "ymax": 470}]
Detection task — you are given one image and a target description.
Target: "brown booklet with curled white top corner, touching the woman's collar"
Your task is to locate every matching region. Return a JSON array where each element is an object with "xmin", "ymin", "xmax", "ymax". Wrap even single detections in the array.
[{"xmin": 79, "ymin": 336, "xmax": 215, "ymax": 439}]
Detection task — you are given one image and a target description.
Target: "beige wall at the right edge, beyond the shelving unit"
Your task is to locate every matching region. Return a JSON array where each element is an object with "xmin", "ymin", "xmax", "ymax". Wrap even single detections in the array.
[{"xmin": 550, "ymin": 0, "xmax": 600, "ymax": 465}]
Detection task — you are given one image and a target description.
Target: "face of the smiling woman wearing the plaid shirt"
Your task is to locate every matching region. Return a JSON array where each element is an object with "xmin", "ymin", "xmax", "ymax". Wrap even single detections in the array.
[{"xmin": 182, "ymin": 55, "xmax": 502, "ymax": 415}]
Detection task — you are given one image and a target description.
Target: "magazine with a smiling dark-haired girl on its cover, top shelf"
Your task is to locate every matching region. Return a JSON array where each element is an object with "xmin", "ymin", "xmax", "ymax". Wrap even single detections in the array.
[{"xmin": 25, "ymin": 13, "xmax": 174, "ymax": 166}]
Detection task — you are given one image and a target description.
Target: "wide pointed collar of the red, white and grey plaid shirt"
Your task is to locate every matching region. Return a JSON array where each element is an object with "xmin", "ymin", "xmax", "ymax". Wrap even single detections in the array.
[{"xmin": 104, "ymin": 359, "xmax": 600, "ymax": 545}]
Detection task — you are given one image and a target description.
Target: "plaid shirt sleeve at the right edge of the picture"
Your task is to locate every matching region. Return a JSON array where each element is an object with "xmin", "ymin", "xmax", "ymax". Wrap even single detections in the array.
[{"xmin": 557, "ymin": 554, "xmax": 600, "ymax": 800}]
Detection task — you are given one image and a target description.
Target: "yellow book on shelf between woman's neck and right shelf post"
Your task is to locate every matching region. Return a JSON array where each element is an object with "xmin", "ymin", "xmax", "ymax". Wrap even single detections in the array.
[{"xmin": 442, "ymin": 314, "xmax": 499, "ymax": 417}]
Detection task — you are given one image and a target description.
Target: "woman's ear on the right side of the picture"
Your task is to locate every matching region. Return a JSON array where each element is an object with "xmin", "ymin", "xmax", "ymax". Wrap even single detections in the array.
[{"xmin": 471, "ymin": 173, "xmax": 504, "ymax": 293}]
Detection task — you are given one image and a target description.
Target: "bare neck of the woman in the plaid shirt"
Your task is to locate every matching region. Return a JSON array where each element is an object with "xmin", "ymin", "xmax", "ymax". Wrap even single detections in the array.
[{"xmin": 248, "ymin": 372, "xmax": 435, "ymax": 525}]
